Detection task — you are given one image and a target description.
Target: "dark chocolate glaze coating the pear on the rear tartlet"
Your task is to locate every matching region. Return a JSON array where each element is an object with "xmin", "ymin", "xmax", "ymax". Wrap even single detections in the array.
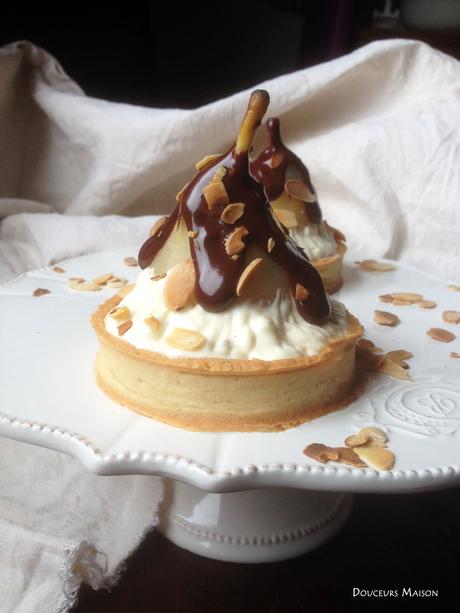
[{"xmin": 250, "ymin": 117, "xmax": 322, "ymax": 223}]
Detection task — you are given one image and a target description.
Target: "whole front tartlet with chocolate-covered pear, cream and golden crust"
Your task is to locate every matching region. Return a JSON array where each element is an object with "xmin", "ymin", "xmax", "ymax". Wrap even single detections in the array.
[{"xmin": 92, "ymin": 90, "xmax": 362, "ymax": 431}]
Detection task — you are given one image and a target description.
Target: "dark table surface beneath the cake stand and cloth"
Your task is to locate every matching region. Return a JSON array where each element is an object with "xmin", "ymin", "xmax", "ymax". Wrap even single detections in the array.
[{"xmin": 74, "ymin": 488, "xmax": 460, "ymax": 613}]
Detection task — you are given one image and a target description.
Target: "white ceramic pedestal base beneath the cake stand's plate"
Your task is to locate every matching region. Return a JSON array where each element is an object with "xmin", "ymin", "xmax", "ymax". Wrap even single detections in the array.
[{"xmin": 159, "ymin": 480, "xmax": 352, "ymax": 563}]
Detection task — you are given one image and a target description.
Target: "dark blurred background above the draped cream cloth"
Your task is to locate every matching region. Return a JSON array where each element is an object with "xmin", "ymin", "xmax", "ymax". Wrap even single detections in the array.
[{"xmin": 0, "ymin": 0, "xmax": 460, "ymax": 108}]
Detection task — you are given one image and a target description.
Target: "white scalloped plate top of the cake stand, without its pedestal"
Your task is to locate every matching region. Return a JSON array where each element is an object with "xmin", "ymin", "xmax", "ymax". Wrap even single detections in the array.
[{"xmin": 0, "ymin": 248, "xmax": 460, "ymax": 492}]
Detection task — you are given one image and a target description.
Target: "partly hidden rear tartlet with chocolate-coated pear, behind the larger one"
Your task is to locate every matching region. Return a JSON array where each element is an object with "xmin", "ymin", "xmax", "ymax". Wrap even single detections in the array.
[{"xmin": 250, "ymin": 117, "xmax": 347, "ymax": 294}]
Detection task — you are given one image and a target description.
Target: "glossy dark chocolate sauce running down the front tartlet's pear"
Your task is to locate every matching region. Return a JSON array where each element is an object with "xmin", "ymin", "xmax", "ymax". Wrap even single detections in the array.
[{"xmin": 138, "ymin": 145, "xmax": 331, "ymax": 323}]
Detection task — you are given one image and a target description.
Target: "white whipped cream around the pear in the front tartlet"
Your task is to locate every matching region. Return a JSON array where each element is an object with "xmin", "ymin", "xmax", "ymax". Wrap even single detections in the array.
[{"xmin": 105, "ymin": 267, "xmax": 347, "ymax": 360}]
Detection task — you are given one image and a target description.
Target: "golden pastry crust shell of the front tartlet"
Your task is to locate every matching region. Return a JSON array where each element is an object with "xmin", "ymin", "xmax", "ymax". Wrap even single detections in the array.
[{"xmin": 92, "ymin": 296, "xmax": 362, "ymax": 431}]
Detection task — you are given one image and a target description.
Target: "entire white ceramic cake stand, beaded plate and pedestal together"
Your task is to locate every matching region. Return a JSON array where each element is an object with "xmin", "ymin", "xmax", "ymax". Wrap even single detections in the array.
[{"xmin": 0, "ymin": 248, "xmax": 460, "ymax": 562}]
